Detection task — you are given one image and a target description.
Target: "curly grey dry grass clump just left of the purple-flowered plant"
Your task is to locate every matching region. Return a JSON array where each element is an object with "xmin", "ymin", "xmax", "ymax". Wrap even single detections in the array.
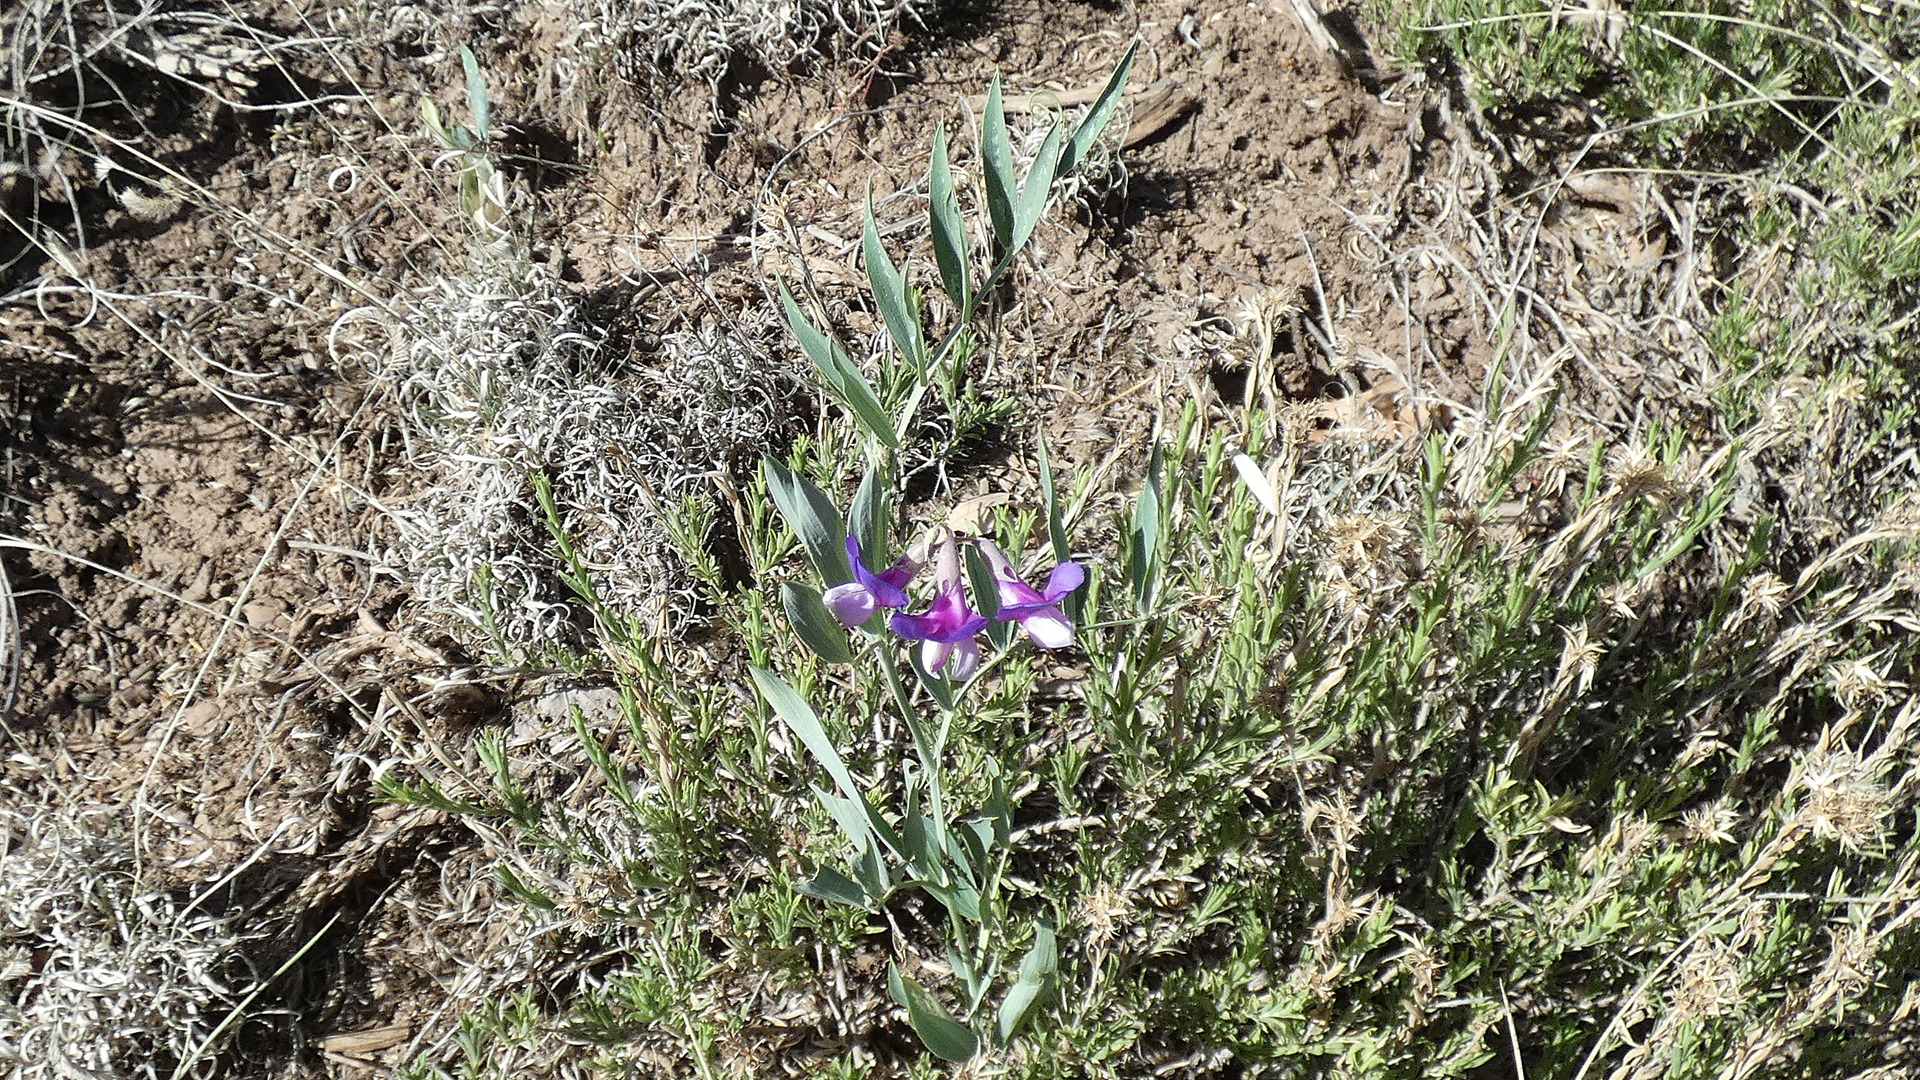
[{"xmin": 390, "ymin": 271, "xmax": 787, "ymax": 661}]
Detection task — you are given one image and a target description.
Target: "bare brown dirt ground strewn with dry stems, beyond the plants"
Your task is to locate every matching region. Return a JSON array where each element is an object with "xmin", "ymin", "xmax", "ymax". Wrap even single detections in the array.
[{"xmin": 0, "ymin": 0, "xmax": 1582, "ymax": 1074}]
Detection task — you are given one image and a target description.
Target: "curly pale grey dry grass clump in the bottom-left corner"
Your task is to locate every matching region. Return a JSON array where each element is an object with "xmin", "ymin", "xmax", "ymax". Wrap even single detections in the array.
[{"xmin": 0, "ymin": 792, "xmax": 252, "ymax": 1080}]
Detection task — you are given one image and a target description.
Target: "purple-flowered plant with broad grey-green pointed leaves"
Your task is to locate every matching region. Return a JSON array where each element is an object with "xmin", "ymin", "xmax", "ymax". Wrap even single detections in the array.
[{"xmin": 753, "ymin": 48, "xmax": 1133, "ymax": 1061}]
